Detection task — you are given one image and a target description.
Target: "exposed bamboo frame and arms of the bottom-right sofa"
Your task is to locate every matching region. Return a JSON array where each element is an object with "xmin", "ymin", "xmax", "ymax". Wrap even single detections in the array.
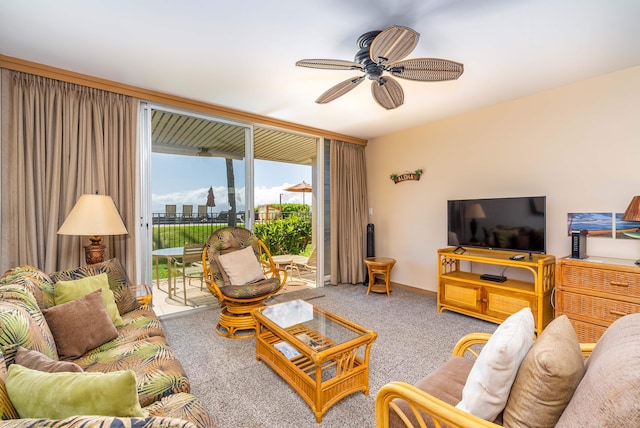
[{"xmin": 376, "ymin": 333, "xmax": 595, "ymax": 428}]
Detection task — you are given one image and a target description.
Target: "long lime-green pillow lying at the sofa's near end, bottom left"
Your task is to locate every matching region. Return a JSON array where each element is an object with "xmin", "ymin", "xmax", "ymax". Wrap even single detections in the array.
[{"xmin": 6, "ymin": 364, "xmax": 147, "ymax": 419}]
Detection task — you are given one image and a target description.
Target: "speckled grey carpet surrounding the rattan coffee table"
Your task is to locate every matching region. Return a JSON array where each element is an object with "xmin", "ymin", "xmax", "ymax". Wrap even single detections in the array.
[{"xmin": 161, "ymin": 285, "xmax": 497, "ymax": 428}]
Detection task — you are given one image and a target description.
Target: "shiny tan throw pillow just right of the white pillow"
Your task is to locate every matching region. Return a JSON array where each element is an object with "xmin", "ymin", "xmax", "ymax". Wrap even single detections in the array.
[{"xmin": 503, "ymin": 315, "xmax": 584, "ymax": 428}]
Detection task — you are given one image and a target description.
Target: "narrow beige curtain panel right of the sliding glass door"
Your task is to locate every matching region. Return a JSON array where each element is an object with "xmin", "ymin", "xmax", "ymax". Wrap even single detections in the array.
[{"xmin": 330, "ymin": 141, "xmax": 367, "ymax": 285}]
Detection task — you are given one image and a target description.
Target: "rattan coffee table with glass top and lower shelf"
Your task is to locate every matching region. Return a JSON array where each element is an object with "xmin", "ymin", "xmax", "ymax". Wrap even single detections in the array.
[{"xmin": 253, "ymin": 300, "xmax": 377, "ymax": 422}]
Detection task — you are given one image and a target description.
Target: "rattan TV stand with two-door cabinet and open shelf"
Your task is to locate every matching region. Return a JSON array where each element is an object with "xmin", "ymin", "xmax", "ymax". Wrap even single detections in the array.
[{"xmin": 438, "ymin": 247, "xmax": 556, "ymax": 333}]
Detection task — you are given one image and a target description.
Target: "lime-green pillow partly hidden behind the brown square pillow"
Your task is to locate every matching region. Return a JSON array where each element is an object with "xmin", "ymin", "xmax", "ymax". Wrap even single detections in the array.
[{"xmin": 54, "ymin": 273, "xmax": 122, "ymax": 327}]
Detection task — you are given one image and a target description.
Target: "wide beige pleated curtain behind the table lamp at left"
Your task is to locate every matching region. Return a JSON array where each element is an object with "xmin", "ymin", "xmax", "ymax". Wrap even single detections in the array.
[{"xmin": 0, "ymin": 70, "xmax": 138, "ymax": 275}]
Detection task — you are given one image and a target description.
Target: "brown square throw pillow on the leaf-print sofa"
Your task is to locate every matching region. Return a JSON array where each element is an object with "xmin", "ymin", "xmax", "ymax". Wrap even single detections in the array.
[{"xmin": 42, "ymin": 289, "xmax": 118, "ymax": 360}]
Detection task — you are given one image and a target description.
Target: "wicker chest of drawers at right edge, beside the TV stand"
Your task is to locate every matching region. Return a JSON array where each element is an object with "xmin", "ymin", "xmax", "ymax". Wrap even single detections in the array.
[{"xmin": 555, "ymin": 256, "xmax": 640, "ymax": 342}]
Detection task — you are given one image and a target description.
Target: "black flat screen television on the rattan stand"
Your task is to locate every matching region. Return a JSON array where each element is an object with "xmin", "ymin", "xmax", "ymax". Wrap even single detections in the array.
[{"xmin": 447, "ymin": 196, "xmax": 546, "ymax": 253}]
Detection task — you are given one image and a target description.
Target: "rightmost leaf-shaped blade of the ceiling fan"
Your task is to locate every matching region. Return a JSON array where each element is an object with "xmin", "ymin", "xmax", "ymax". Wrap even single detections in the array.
[{"xmin": 388, "ymin": 58, "xmax": 464, "ymax": 82}]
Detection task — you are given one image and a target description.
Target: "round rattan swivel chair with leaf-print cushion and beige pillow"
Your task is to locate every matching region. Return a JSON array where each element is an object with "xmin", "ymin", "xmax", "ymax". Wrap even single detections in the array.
[{"xmin": 202, "ymin": 227, "xmax": 287, "ymax": 339}]
